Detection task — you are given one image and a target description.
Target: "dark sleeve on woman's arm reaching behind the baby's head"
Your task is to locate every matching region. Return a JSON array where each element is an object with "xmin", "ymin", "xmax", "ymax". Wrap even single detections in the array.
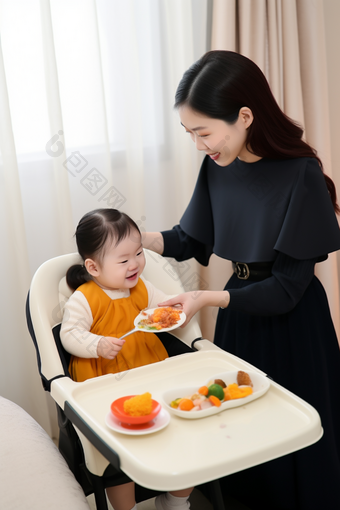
[{"xmin": 161, "ymin": 225, "xmax": 213, "ymax": 266}]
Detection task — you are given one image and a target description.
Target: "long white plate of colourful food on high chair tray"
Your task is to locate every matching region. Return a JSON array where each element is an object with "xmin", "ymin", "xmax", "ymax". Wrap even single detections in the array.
[{"xmin": 162, "ymin": 370, "xmax": 270, "ymax": 420}]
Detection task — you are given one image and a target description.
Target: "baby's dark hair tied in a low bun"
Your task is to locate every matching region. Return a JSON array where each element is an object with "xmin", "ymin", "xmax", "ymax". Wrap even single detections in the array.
[{"xmin": 66, "ymin": 209, "xmax": 140, "ymax": 290}]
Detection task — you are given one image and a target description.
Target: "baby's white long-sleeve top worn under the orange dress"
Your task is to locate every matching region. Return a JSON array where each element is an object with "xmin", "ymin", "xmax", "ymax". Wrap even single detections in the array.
[{"xmin": 60, "ymin": 276, "xmax": 173, "ymax": 358}]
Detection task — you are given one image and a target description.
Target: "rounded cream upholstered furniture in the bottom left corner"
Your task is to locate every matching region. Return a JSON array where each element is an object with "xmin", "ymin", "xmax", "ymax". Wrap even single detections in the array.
[{"xmin": 0, "ymin": 396, "xmax": 89, "ymax": 510}]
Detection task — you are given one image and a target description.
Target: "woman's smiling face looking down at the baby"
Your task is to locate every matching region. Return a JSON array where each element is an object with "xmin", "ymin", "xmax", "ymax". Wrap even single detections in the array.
[{"xmin": 178, "ymin": 105, "xmax": 261, "ymax": 166}]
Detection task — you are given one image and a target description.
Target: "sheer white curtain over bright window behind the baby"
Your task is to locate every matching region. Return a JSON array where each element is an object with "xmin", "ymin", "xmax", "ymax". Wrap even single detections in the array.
[{"xmin": 0, "ymin": 0, "xmax": 209, "ymax": 435}]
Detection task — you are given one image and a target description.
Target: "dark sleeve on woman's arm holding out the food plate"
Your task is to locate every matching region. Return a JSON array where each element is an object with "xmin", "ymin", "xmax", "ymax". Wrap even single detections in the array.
[{"xmin": 228, "ymin": 253, "xmax": 317, "ymax": 316}]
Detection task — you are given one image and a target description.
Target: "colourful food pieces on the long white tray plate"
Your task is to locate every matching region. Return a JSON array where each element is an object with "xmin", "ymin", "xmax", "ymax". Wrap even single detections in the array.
[{"xmin": 170, "ymin": 370, "xmax": 253, "ymax": 412}]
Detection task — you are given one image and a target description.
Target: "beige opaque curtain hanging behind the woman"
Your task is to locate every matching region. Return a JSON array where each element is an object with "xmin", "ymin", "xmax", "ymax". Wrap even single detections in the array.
[{"xmin": 202, "ymin": 0, "xmax": 340, "ymax": 339}]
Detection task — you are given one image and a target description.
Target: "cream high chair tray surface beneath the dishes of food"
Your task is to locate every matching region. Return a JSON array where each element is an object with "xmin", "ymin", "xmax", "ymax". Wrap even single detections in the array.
[{"xmin": 52, "ymin": 341, "xmax": 323, "ymax": 491}]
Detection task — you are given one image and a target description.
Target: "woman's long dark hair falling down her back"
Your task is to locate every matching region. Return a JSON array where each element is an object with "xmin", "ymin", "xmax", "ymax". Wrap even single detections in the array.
[{"xmin": 175, "ymin": 50, "xmax": 340, "ymax": 213}]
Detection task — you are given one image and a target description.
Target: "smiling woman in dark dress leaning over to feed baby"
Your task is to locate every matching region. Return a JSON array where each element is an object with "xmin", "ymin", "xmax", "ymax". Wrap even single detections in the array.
[{"xmin": 144, "ymin": 51, "xmax": 340, "ymax": 510}]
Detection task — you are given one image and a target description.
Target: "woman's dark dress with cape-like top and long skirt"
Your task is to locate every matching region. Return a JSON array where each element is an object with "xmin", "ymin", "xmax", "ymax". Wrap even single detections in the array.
[{"xmin": 163, "ymin": 158, "xmax": 340, "ymax": 510}]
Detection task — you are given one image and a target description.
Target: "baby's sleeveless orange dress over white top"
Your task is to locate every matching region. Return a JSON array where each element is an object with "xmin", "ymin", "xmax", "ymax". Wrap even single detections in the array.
[{"xmin": 69, "ymin": 279, "xmax": 168, "ymax": 382}]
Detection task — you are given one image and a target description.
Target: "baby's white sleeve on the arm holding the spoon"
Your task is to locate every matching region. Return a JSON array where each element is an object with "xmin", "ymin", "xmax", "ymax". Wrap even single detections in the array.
[{"xmin": 60, "ymin": 291, "xmax": 101, "ymax": 358}]
